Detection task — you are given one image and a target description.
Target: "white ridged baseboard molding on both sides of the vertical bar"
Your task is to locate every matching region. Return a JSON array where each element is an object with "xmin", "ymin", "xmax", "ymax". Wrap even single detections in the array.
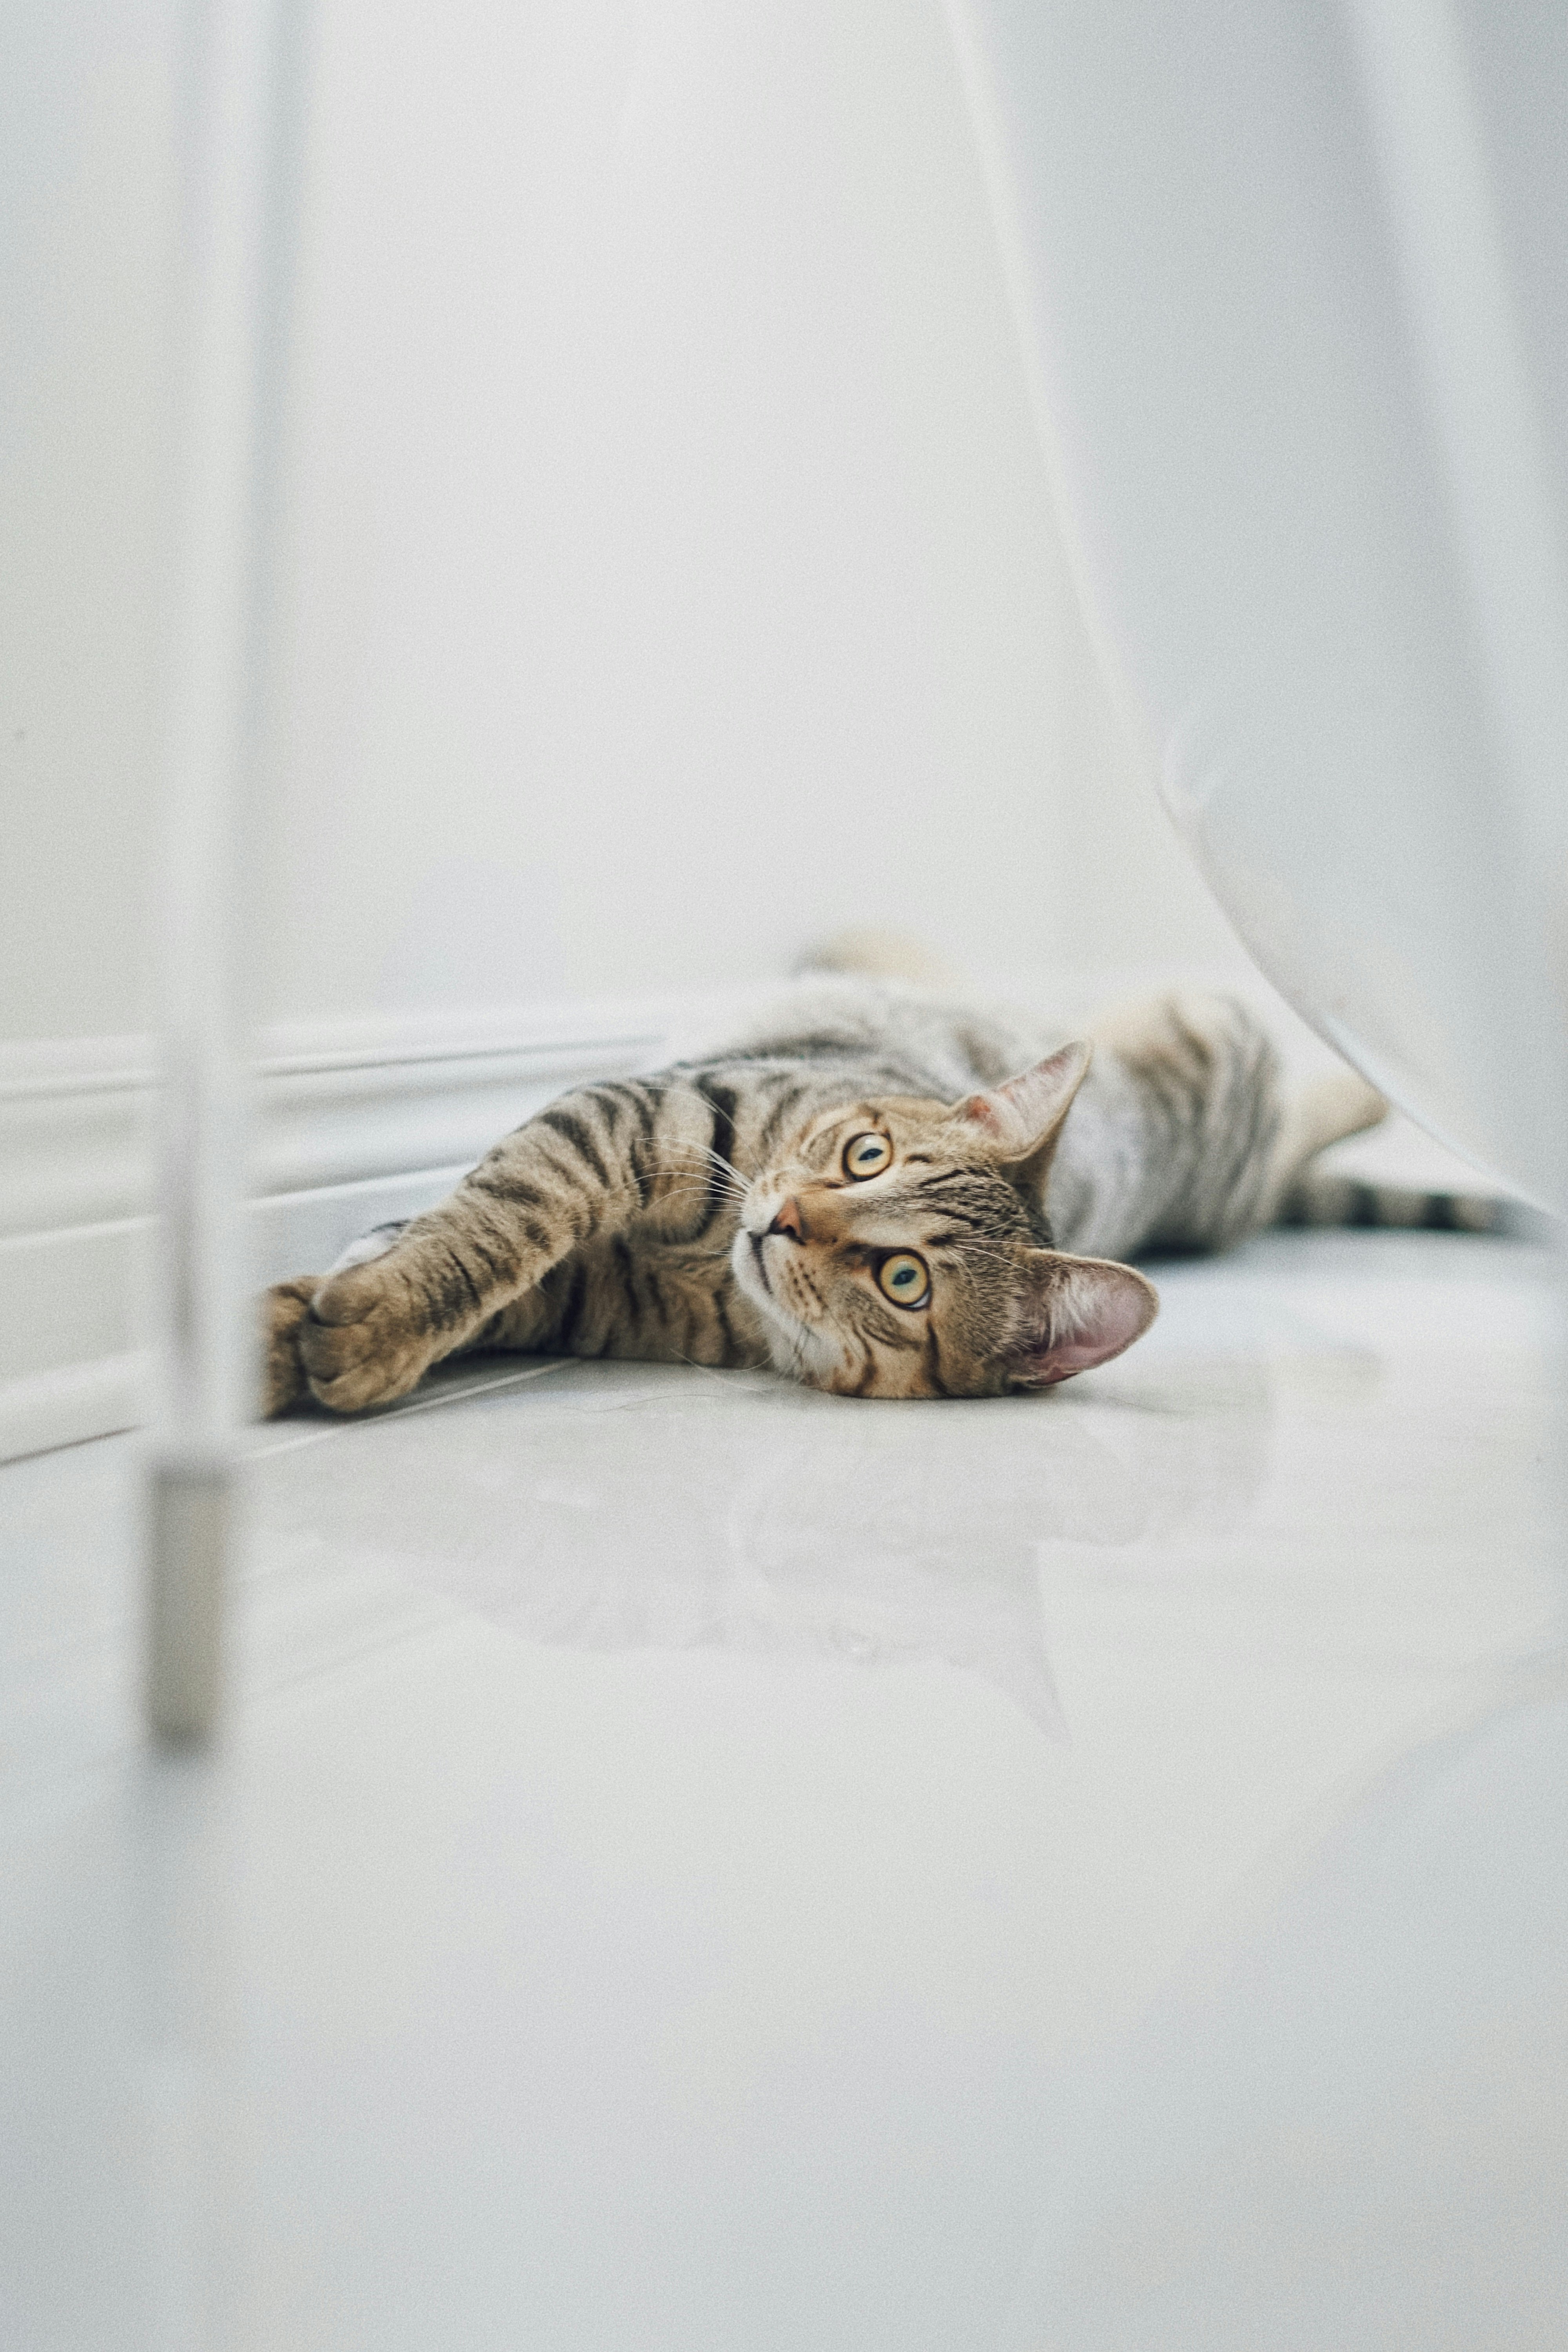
[{"xmin": 0, "ymin": 990, "xmax": 780, "ymax": 1461}]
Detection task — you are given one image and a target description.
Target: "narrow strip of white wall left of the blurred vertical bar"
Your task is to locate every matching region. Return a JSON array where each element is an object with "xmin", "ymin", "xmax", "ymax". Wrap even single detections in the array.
[{"xmin": 0, "ymin": 0, "xmax": 176, "ymax": 1040}]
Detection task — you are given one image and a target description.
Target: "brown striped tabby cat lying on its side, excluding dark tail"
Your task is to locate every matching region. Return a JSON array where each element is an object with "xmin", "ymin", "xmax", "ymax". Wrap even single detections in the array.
[{"xmin": 266, "ymin": 978, "xmax": 1420, "ymax": 1414}]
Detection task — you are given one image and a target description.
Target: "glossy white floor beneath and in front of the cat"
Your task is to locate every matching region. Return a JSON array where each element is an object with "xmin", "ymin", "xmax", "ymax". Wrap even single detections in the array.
[{"xmin": 0, "ymin": 1235, "xmax": 1568, "ymax": 2352}]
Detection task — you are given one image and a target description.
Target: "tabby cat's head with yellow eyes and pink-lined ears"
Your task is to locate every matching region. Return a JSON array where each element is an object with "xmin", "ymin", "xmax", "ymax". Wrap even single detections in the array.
[{"xmin": 731, "ymin": 1044, "xmax": 1159, "ymax": 1397}]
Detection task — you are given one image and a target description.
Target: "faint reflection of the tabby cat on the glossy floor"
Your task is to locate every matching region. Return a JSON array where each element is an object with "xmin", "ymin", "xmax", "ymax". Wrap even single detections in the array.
[{"xmin": 256, "ymin": 1348, "xmax": 1375, "ymax": 1733}]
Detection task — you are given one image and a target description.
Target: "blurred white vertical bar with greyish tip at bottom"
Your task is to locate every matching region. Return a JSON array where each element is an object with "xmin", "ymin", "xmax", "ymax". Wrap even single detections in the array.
[{"xmin": 146, "ymin": 0, "xmax": 294, "ymax": 1743}]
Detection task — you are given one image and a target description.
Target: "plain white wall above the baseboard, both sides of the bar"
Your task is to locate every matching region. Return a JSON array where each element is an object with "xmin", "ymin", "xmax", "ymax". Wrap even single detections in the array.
[{"xmin": 0, "ymin": 0, "xmax": 1236, "ymax": 1040}]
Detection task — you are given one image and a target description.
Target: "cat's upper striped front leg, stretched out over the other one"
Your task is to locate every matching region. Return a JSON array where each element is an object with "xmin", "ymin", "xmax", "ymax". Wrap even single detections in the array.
[{"xmin": 270, "ymin": 1080, "xmax": 712, "ymax": 1414}]
